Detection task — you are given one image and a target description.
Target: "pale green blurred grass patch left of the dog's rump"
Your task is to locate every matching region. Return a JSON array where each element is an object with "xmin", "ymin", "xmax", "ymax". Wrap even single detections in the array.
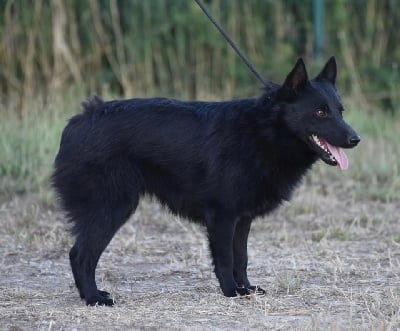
[{"xmin": 0, "ymin": 96, "xmax": 66, "ymax": 197}]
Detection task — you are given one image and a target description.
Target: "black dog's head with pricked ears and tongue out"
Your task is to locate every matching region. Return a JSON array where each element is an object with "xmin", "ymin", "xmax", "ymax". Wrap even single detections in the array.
[{"xmin": 275, "ymin": 57, "xmax": 360, "ymax": 170}]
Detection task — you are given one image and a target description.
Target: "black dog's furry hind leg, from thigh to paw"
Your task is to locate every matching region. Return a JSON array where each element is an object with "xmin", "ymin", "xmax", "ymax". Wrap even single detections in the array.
[{"xmin": 64, "ymin": 160, "xmax": 142, "ymax": 306}]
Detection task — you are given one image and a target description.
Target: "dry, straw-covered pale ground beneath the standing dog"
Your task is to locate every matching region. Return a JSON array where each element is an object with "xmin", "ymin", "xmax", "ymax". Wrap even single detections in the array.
[{"xmin": 0, "ymin": 175, "xmax": 400, "ymax": 330}]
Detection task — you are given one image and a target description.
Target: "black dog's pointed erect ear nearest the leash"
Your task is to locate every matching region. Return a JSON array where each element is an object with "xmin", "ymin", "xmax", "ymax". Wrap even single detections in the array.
[{"xmin": 278, "ymin": 58, "xmax": 308, "ymax": 98}]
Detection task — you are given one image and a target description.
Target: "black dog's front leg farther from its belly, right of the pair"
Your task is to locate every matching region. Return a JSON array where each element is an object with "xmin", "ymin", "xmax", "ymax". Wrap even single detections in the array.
[{"xmin": 233, "ymin": 219, "xmax": 265, "ymax": 295}]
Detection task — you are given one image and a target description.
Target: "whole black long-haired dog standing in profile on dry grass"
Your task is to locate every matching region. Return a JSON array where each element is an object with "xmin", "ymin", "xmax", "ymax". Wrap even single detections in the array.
[{"xmin": 53, "ymin": 57, "xmax": 360, "ymax": 305}]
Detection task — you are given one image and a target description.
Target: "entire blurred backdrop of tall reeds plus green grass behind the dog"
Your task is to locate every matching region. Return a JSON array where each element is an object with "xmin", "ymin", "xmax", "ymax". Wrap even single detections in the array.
[{"xmin": 0, "ymin": 0, "xmax": 400, "ymax": 200}]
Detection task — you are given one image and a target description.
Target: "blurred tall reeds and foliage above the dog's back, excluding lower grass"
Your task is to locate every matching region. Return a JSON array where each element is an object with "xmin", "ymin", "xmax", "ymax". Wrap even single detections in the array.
[{"xmin": 0, "ymin": 0, "xmax": 400, "ymax": 115}]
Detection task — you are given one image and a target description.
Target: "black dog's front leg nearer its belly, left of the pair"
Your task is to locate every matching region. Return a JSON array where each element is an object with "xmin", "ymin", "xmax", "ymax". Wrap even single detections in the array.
[{"xmin": 206, "ymin": 212, "xmax": 237, "ymax": 297}]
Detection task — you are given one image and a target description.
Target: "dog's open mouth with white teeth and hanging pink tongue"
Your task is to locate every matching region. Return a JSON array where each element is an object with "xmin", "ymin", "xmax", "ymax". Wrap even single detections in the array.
[{"xmin": 309, "ymin": 134, "xmax": 349, "ymax": 170}]
